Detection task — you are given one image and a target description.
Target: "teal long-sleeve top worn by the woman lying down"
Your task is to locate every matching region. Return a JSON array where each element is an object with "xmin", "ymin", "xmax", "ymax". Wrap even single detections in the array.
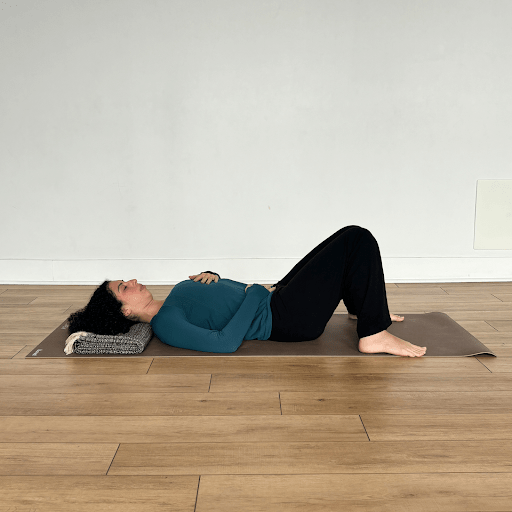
[{"xmin": 151, "ymin": 279, "xmax": 274, "ymax": 353}]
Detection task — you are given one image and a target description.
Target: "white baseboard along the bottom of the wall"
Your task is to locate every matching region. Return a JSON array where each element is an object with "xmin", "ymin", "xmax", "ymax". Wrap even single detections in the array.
[{"xmin": 0, "ymin": 257, "xmax": 512, "ymax": 285}]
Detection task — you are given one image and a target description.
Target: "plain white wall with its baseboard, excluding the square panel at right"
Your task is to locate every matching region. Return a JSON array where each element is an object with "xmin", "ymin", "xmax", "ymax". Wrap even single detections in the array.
[{"xmin": 0, "ymin": 0, "xmax": 512, "ymax": 283}]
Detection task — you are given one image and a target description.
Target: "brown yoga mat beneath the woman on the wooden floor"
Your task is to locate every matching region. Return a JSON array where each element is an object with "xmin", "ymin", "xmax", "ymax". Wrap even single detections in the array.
[{"xmin": 27, "ymin": 313, "xmax": 496, "ymax": 358}]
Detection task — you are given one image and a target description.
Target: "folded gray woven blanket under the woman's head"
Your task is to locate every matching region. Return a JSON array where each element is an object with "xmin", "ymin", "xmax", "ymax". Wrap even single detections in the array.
[{"xmin": 64, "ymin": 323, "xmax": 153, "ymax": 355}]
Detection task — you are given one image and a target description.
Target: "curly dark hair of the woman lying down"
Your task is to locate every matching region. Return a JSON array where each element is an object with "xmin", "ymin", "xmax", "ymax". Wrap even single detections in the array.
[{"xmin": 67, "ymin": 281, "xmax": 138, "ymax": 335}]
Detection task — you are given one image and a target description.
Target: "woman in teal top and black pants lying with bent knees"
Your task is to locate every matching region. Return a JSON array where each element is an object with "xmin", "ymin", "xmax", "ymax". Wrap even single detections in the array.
[{"xmin": 68, "ymin": 226, "xmax": 426, "ymax": 357}]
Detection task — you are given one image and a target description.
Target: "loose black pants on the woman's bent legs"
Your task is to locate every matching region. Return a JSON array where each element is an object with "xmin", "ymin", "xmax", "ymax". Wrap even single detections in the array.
[{"xmin": 269, "ymin": 226, "xmax": 391, "ymax": 341}]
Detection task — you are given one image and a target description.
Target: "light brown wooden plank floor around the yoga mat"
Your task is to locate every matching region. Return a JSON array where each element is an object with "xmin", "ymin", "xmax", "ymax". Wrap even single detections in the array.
[{"xmin": 0, "ymin": 283, "xmax": 512, "ymax": 512}]
